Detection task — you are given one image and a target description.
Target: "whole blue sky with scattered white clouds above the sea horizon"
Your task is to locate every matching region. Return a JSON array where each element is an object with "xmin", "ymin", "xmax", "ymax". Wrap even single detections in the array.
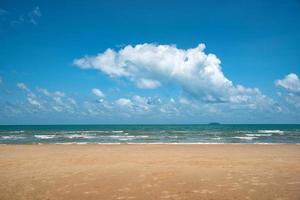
[{"xmin": 0, "ymin": 0, "xmax": 300, "ymax": 124}]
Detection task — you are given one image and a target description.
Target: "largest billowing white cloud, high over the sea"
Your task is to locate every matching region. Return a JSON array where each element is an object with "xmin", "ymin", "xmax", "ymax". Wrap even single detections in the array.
[{"xmin": 74, "ymin": 43, "xmax": 270, "ymax": 103}]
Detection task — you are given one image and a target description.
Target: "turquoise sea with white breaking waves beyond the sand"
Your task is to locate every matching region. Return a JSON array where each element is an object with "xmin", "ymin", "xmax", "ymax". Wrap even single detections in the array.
[{"xmin": 0, "ymin": 124, "xmax": 300, "ymax": 144}]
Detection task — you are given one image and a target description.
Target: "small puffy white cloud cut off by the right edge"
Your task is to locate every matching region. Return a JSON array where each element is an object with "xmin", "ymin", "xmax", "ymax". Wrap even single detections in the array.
[{"xmin": 275, "ymin": 73, "xmax": 300, "ymax": 93}]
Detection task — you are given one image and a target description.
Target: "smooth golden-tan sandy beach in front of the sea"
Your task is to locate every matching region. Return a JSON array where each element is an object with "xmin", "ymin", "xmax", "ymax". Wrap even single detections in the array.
[{"xmin": 0, "ymin": 144, "xmax": 300, "ymax": 200}]
